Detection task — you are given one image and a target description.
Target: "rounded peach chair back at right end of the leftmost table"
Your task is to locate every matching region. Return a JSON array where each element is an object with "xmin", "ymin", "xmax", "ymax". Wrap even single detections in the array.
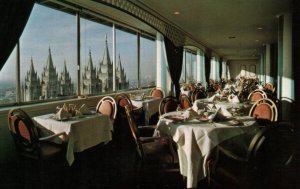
[{"xmin": 96, "ymin": 96, "xmax": 117, "ymax": 120}]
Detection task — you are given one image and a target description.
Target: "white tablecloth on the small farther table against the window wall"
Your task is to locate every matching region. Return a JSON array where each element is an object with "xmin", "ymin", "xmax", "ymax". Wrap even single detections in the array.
[{"xmin": 131, "ymin": 97, "xmax": 161, "ymax": 125}]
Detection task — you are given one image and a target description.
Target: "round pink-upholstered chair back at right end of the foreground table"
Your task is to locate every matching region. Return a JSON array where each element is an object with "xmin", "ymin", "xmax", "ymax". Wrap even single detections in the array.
[{"xmin": 249, "ymin": 98, "xmax": 278, "ymax": 121}]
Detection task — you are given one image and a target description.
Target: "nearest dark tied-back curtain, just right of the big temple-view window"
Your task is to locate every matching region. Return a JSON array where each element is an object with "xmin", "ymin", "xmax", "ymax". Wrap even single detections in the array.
[{"xmin": 164, "ymin": 36, "xmax": 183, "ymax": 99}]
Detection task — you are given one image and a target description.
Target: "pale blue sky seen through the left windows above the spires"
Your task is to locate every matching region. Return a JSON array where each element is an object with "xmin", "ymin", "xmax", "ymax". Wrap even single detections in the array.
[{"xmin": 0, "ymin": 4, "xmax": 156, "ymax": 85}]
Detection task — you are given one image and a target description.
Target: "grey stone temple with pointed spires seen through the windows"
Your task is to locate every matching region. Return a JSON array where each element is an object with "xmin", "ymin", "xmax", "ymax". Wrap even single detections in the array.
[{"xmin": 22, "ymin": 35, "xmax": 129, "ymax": 101}]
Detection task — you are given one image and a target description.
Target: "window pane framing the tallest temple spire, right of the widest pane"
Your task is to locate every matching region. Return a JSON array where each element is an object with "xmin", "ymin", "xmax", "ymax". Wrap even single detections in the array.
[{"xmin": 80, "ymin": 18, "xmax": 113, "ymax": 95}]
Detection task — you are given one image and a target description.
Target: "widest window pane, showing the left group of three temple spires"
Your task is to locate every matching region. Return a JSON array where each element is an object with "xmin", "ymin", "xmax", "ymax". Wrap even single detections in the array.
[{"xmin": 19, "ymin": 4, "xmax": 77, "ymax": 102}]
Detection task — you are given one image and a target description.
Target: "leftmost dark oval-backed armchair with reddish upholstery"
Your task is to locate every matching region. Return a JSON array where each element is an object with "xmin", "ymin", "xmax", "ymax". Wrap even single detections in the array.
[{"xmin": 8, "ymin": 108, "xmax": 67, "ymax": 168}]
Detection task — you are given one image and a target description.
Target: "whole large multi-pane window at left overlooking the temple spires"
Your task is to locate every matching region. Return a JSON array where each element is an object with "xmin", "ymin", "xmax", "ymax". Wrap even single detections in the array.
[{"xmin": 0, "ymin": 3, "xmax": 156, "ymax": 105}]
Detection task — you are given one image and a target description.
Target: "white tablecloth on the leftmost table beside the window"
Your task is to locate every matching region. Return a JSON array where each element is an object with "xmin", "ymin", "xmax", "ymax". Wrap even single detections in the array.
[{"xmin": 33, "ymin": 113, "xmax": 113, "ymax": 165}]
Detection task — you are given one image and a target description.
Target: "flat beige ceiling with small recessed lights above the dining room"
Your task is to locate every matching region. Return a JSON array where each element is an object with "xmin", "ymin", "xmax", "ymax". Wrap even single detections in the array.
[{"xmin": 42, "ymin": 0, "xmax": 292, "ymax": 61}]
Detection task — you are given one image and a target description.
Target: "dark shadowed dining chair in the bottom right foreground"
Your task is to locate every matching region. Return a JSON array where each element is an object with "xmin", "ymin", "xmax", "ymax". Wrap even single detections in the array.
[{"xmin": 206, "ymin": 122, "xmax": 295, "ymax": 189}]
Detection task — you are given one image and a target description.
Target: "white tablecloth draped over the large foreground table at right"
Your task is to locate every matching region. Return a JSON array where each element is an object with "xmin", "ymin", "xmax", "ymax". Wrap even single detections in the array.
[{"xmin": 157, "ymin": 112, "xmax": 257, "ymax": 188}]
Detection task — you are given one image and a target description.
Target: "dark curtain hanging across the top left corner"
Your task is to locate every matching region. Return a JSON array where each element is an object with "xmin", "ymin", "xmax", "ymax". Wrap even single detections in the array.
[{"xmin": 0, "ymin": 0, "xmax": 35, "ymax": 71}]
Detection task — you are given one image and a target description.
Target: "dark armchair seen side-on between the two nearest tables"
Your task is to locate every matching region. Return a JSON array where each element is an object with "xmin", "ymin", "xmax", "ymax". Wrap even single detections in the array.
[{"xmin": 125, "ymin": 105, "xmax": 178, "ymax": 166}]
